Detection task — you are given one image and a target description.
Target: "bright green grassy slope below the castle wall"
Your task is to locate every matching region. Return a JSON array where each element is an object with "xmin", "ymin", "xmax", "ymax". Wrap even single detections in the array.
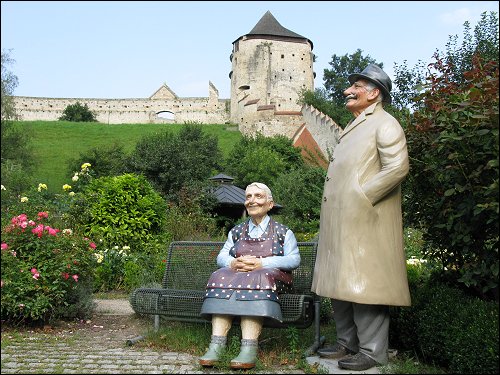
[{"xmin": 12, "ymin": 121, "xmax": 241, "ymax": 192}]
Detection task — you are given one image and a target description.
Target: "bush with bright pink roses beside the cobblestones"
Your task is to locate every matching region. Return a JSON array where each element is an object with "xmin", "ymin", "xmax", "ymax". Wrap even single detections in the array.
[{"xmin": 1, "ymin": 211, "xmax": 95, "ymax": 324}]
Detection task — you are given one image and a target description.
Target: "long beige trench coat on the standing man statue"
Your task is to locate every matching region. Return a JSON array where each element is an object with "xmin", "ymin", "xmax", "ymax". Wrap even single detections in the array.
[{"xmin": 312, "ymin": 103, "xmax": 410, "ymax": 306}]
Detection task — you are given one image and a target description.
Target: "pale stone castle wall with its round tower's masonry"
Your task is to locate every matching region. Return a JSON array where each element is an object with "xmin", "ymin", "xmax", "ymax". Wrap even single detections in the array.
[{"xmin": 14, "ymin": 14, "xmax": 314, "ymax": 138}]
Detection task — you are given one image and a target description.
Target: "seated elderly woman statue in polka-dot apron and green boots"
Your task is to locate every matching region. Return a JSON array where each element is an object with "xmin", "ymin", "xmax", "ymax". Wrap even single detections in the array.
[{"xmin": 199, "ymin": 182, "xmax": 300, "ymax": 369}]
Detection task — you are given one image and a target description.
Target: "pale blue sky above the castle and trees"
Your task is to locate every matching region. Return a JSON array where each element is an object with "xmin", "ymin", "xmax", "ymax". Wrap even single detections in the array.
[{"xmin": 1, "ymin": 1, "xmax": 499, "ymax": 99}]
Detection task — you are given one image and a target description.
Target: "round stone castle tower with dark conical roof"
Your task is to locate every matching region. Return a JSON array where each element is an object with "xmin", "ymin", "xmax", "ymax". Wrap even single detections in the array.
[{"xmin": 229, "ymin": 11, "xmax": 314, "ymax": 138}]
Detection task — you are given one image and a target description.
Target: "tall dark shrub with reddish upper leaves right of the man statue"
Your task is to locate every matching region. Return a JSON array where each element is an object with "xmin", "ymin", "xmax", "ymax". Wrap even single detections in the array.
[{"xmin": 407, "ymin": 55, "xmax": 499, "ymax": 296}]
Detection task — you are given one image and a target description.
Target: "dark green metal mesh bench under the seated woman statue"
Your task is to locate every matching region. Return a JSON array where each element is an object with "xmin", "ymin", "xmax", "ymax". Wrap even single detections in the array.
[{"xmin": 130, "ymin": 241, "xmax": 324, "ymax": 355}]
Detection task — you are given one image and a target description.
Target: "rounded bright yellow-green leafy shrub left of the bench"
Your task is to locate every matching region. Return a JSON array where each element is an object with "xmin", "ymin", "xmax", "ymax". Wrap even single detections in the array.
[{"xmin": 71, "ymin": 174, "xmax": 166, "ymax": 251}]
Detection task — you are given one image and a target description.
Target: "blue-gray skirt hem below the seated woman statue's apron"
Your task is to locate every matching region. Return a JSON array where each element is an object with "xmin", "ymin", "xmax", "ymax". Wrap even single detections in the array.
[{"xmin": 200, "ymin": 293, "xmax": 283, "ymax": 323}]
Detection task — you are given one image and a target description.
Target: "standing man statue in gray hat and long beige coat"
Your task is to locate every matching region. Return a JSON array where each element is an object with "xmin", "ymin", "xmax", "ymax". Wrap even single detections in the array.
[{"xmin": 312, "ymin": 64, "xmax": 411, "ymax": 371}]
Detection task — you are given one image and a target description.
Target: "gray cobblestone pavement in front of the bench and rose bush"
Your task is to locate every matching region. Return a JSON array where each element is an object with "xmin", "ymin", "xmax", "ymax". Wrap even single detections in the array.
[{"xmin": 1, "ymin": 300, "xmax": 379, "ymax": 374}]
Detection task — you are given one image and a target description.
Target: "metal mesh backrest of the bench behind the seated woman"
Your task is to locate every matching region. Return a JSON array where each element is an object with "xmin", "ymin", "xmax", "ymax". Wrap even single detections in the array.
[{"xmin": 162, "ymin": 241, "xmax": 317, "ymax": 294}]
